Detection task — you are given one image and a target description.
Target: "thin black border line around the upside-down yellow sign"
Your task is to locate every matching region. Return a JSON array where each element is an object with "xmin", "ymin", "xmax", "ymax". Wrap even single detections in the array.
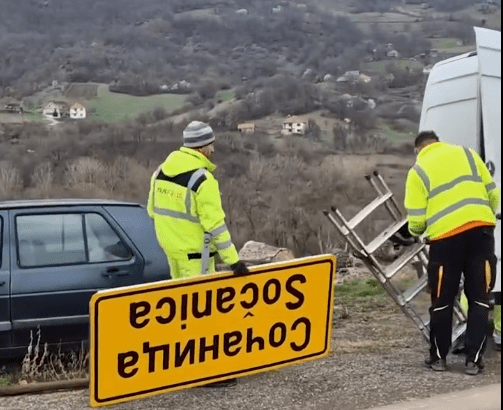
[{"xmin": 94, "ymin": 258, "xmax": 335, "ymax": 403}]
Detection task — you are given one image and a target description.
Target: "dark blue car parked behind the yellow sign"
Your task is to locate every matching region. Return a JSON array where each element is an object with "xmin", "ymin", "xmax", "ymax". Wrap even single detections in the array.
[{"xmin": 0, "ymin": 200, "xmax": 170, "ymax": 358}]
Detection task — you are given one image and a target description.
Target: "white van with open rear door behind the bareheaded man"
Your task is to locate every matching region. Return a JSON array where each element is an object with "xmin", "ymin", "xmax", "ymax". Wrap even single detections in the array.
[{"xmin": 419, "ymin": 28, "xmax": 501, "ymax": 305}]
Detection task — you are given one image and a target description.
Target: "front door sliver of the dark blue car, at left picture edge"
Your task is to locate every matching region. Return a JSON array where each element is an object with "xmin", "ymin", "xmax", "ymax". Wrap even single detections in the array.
[{"xmin": 0, "ymin": 211, "xmax": 12, "ymax": 349}]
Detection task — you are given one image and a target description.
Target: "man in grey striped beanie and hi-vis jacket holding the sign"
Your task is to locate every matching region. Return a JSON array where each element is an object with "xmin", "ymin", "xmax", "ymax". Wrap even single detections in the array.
[{"xmin": 147, "ymin": 121, "xmax": 248, "ymax": 279}]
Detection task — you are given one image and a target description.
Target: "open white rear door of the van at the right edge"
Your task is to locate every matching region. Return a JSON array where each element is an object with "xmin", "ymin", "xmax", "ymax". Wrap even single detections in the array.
[{"xmin": 475, "ymin": 28, "xmax": 501, "ymax": 293}]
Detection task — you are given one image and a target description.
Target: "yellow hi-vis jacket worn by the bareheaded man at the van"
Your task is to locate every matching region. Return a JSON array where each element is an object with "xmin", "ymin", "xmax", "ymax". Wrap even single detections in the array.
[{"xmin": 405, "ymin": 142, "xmax": 500, "ymax": 240}]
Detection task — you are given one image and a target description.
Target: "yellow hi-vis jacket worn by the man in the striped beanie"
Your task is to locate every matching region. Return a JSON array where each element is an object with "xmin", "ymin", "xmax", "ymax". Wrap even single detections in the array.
[{"xmin": 147, "ymin": 147, "xmax": 239, "ymax": 265}]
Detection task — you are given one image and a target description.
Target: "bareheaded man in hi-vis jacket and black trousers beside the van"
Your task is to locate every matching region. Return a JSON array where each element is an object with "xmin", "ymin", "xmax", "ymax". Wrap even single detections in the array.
[{"xmin": 405, "ymin": 131, "xmax": 500, "ymax": 375}]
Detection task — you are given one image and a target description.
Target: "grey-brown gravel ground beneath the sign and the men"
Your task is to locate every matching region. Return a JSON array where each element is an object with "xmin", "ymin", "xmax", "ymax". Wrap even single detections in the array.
[{"xmin": 0, "ymin": 304, "xmax": 501, "ymax": 410}]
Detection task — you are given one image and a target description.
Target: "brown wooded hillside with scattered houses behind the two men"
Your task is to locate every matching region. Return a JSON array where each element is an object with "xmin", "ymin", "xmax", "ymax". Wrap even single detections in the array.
[{"xmin": 0, "ymin": 0, "xmax": 501, "ymax": 248}]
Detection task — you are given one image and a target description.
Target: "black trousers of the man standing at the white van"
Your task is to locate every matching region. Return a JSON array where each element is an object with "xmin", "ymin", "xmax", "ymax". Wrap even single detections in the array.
[{"xmin": 428, "ymin": 227, "xmax": 496, "ymax": 361}]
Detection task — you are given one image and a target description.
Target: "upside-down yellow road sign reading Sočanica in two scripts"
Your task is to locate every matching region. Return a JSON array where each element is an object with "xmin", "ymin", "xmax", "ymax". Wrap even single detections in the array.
[{"xmin": 90, "ymin": 256, "xmax": 335, "ymax": 407}]
